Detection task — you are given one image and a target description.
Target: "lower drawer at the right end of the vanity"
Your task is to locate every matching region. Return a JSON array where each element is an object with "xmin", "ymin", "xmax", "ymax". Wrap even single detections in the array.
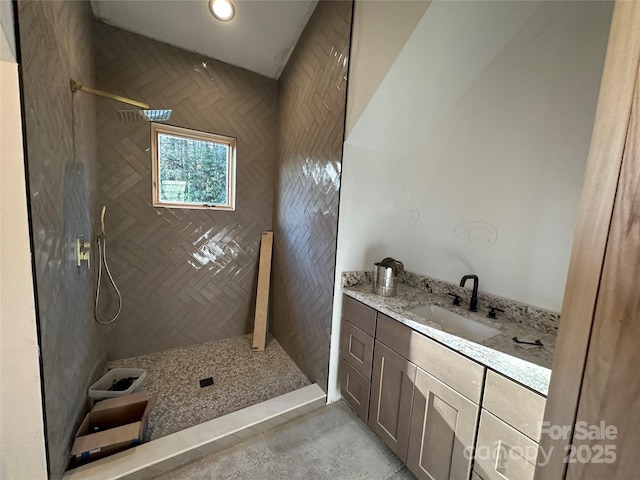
[{"xmin": 474, "ymin": 409, "xmax": 538, "ymax": 480}]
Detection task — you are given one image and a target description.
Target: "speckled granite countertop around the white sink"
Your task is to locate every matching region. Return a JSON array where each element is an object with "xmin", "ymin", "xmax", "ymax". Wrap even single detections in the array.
[{"xmin": 342, "ymin": 283, "xmax": 556, "ymax": 396}]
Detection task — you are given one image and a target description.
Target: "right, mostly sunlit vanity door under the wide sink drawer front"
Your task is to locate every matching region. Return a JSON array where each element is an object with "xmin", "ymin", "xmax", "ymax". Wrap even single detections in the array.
[{"xmin": 407, "ymin": 368, "xmax": 480, "ymax": 480}]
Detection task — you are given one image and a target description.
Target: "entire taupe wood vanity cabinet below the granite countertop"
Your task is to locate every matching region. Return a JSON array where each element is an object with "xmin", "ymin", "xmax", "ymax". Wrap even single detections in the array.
[{"xmin": 340, "ymin": 296, "xmax": 546, "ymax": 480}]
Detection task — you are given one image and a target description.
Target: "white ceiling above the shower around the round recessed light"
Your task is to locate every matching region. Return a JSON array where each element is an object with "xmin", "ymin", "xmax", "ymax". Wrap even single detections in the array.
[{"xmin": 91, "ymin": 0, "xmax": 317, "ymax": 79}]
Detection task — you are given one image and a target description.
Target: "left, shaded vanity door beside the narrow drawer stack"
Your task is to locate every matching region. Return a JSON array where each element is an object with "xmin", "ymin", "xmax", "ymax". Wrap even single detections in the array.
[{"xmin": 369, "ymin": 342, "xmax": 416, "ymax": 462}]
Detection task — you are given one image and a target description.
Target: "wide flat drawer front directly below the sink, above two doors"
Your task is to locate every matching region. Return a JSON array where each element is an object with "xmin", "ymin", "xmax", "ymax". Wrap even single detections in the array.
[{"xmin": 376, "ymin": 313, "xmax": 484, "ymax": 404}]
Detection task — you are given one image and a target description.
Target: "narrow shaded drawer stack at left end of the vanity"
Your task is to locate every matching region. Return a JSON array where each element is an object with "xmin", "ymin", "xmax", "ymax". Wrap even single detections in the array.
[{"xmin": 339, "ymin": 297, "xmax": 377, "ymax": 422}]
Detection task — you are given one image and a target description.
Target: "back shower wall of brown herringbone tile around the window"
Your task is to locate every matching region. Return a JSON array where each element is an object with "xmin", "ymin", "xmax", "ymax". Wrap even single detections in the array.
[{"xmin": 95, "ymin": 22, "xmax": 277, "ymax": 359}]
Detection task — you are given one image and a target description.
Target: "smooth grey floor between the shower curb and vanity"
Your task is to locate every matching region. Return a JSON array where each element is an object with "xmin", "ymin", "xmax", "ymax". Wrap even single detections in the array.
[{"xmin": 154, "ymin": 402, "xmax": 415, "ymax": 480}]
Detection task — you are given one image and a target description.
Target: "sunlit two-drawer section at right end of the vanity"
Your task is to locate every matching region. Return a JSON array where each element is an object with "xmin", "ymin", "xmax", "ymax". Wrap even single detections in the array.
[{"xmin": 474, "ymin": 371, "xmax": 546, "ymax": 480}]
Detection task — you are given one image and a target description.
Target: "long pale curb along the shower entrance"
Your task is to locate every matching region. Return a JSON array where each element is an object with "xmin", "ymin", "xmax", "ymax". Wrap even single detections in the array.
[{"xmin": 63, "ymin": 383, "xmax": 326, "ymax": 480}]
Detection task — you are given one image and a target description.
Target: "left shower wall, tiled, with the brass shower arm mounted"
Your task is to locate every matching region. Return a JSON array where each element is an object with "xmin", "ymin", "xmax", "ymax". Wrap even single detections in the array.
[{"xmin": 17, "ymin": 1, "xmax": 105, "ymax": 479}]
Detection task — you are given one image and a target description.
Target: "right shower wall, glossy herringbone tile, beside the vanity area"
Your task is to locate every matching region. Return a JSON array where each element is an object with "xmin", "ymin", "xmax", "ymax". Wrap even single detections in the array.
[{"xmin": 271, "ymin": 1, "xmax": 352, "ymax": 390}]
